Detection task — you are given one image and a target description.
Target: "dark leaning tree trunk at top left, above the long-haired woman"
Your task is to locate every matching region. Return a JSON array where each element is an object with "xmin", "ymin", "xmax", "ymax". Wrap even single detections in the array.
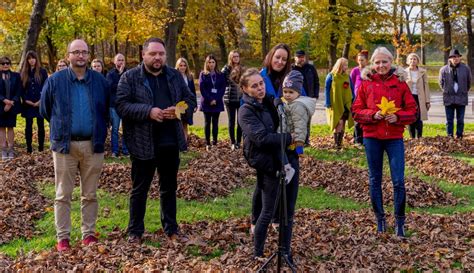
[{"xmin": 20, "ymin": 0, "xmax": 48, "ymax": 67}]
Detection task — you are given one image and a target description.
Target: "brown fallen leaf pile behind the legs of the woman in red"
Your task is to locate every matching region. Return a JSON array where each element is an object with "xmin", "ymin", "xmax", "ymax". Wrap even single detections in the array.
[{"xmin": 300, "ymin": 156, "xmax": 459, "ymax": 207}]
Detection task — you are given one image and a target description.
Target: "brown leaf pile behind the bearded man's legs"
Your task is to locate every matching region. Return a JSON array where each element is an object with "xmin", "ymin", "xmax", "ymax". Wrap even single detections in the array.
[{"xmin": 99, "ymin": 144, "xmax": 253, "ymax": 200}]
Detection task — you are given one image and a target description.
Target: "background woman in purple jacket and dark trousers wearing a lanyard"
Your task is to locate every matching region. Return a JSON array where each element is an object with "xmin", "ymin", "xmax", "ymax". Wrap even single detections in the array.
[{"xmin": 199, "ymin": 55, "xmax": 227, "ymax": 151}]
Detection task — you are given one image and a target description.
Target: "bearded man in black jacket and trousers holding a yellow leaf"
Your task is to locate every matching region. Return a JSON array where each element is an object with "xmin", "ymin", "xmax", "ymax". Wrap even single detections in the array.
[{"xmin": 115, "ymin": 38, "xmax": 196, "ymax": 243}]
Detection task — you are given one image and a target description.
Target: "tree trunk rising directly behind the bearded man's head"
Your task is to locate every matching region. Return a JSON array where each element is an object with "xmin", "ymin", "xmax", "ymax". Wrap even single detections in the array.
[{"xmin": 165, "ymin": 0, "xmax": 187, "ymax": 67}]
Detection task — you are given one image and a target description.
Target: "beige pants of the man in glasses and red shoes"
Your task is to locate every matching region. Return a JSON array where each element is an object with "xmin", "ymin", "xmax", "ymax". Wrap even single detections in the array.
[{"xmin": 53, "ymin": 141, "xmax": 104, "ymax": 240}]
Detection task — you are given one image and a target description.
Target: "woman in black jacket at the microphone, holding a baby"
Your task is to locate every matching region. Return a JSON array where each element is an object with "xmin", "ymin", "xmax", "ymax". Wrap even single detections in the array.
[{"xmin": 238, "ymin": 66, "xmax": 299, "ymax": 261}]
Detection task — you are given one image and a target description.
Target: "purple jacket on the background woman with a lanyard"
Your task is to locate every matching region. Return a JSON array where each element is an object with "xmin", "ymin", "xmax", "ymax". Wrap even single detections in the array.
[{"xmin": 199, "ymin": 72, "xmax": 227, "ymax": 112}]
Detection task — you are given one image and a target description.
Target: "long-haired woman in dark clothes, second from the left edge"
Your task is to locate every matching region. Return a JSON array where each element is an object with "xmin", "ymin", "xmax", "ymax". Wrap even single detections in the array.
[{"xmin": 20, "ymin": 50, "xmax": 48, "ymax": 153}]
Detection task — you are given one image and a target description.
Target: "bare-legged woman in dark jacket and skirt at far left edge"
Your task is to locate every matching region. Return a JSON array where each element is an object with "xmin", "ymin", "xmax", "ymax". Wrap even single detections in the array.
[{"xmin": 0, "ymin": 57, "xmax": 22, "ymax": 160}]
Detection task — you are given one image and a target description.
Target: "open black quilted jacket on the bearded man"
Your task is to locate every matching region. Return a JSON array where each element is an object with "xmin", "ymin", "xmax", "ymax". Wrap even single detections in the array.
[{"xmin": 115, "ymin": 64, "xmax": 196, "ymax": 160}]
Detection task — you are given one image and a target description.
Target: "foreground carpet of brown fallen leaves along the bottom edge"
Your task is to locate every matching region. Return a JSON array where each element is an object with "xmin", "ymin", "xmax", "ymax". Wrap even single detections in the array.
[{"xmin": 0, "ymin": 209, "xmax": 474, "ymax": 272}]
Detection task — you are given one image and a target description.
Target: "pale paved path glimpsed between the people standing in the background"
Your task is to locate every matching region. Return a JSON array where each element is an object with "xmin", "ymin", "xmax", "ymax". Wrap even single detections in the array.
[{"xmin": 194, "ymin": 92, "xmax": 474, "ymax": 127}]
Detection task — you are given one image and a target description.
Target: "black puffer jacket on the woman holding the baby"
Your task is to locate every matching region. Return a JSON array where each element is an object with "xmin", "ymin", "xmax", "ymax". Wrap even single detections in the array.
[{"xmin": 238, "ymin": 94, "xmax": 291, "ymax": 175}]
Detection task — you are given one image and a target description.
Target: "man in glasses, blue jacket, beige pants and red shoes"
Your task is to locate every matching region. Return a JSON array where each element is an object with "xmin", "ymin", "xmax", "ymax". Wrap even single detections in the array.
[{"xmin": 40, "ymin": 40, "xmax": 110, "ymax": 251}]
